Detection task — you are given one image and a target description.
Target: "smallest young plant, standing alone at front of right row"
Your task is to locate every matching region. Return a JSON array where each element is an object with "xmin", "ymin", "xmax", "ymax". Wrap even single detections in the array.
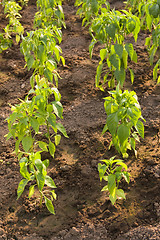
[{"xmin": 98, "ymin": 156, "xmax": 130, "ymax": 205}]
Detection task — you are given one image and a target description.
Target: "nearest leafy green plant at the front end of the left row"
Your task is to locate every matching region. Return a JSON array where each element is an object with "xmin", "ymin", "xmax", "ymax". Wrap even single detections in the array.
[{"xmin": 17, "ymin": 151, "xmax": 56, "ymax": 214}]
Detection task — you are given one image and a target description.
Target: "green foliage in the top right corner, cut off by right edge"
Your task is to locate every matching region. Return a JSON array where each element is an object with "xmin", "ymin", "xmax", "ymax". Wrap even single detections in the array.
[{"xmin": 127, "ymin": 0, "xmax": 160, "ymax": 83}]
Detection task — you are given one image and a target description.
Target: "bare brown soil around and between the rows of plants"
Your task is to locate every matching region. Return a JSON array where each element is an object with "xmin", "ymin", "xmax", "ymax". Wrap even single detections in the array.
[{"xmin": 0, "ymin": 1, "xmax": 160, "ymax": 240}]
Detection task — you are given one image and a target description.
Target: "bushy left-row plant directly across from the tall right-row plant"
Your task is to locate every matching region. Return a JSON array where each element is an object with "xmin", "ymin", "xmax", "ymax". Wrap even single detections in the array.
[{"xmin": 21, "ymin": 26, "xmax": 65, "ymax": 86}]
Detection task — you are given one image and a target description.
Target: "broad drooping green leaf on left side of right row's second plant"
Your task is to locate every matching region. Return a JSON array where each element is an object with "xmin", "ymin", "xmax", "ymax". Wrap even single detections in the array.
[{"xmin": 107, "ymin": 112, "xmax": 118, "ymax": 136}]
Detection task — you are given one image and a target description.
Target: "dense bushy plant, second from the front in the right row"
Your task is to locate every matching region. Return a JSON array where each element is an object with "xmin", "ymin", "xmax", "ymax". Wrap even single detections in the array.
[{"xmin": 102, "ymin": 85, "xmax": 144, "ymax": 158}]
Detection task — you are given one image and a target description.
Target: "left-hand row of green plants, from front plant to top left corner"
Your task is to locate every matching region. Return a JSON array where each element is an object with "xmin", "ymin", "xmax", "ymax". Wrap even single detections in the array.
[{"xmin": 0, "ymin": 0, "xmax": 68, "ymax": 214}]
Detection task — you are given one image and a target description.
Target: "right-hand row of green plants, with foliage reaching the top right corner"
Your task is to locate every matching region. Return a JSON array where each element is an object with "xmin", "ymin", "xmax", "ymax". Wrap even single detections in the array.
[{"xmin": 75, "ymin": 0, "xmax": 160, "ymax": 204}]
